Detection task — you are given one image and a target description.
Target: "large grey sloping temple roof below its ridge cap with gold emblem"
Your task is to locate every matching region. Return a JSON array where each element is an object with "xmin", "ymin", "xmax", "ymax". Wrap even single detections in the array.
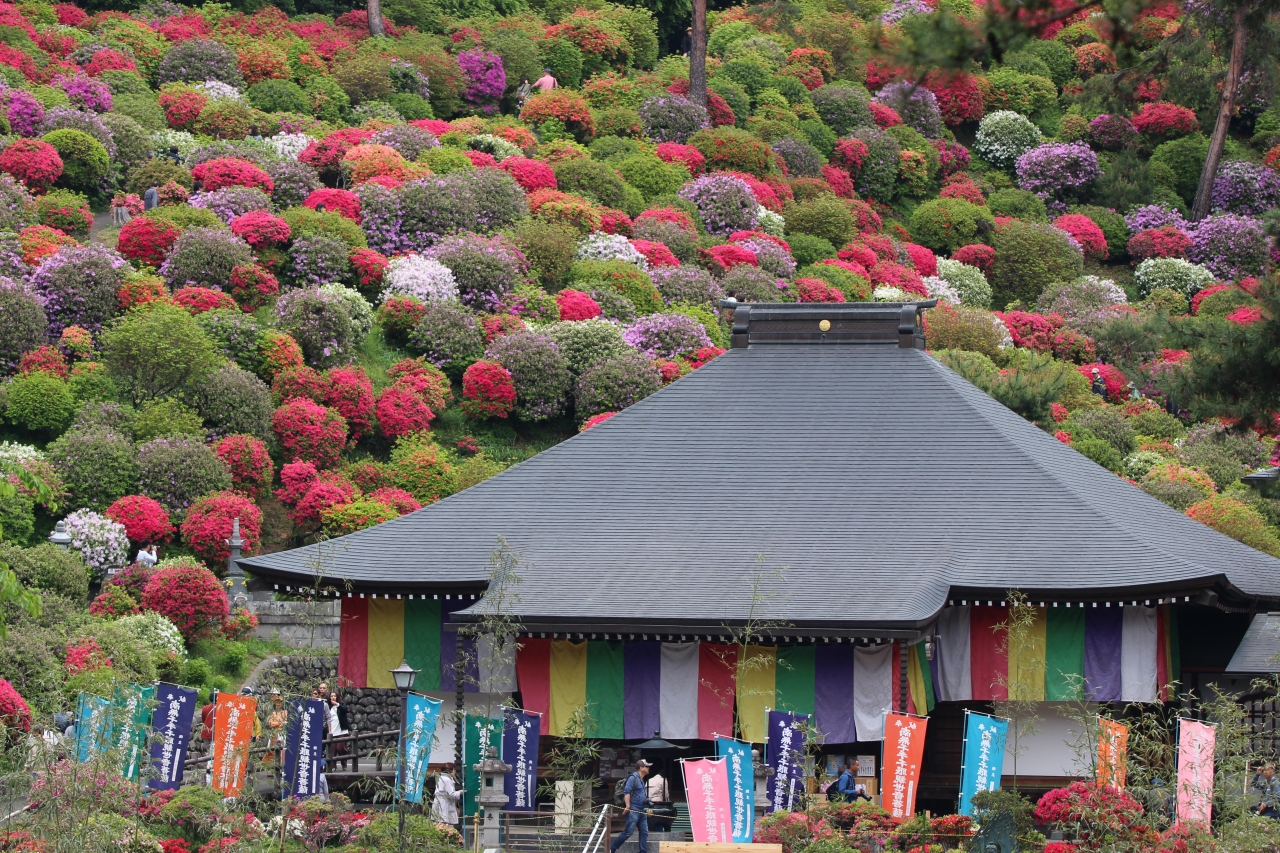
[{"xmin": 242, "ymin": 343, "xmax": 1280, "ymax": 630}]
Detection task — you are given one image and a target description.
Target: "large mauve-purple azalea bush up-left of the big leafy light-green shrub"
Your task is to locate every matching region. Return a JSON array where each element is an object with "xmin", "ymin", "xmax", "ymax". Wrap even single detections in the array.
[{"xmin": 31, "ymin": 243, "xmax": 129, "ymax": 339}]
